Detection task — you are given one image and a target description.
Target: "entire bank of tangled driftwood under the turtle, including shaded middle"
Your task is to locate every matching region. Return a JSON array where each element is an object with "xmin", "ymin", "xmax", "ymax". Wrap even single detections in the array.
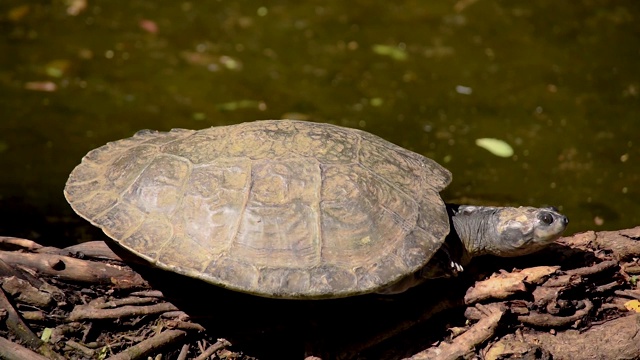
[{"xmin": 0, "ymin": 227, "xmax": 640, "ymax": 359}]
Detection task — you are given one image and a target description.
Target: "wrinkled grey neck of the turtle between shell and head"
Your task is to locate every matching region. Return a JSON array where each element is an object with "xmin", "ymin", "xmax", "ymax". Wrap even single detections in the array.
[{"xmin": 447, "ymin": 204, "xmax": 500, "ymax": 265}]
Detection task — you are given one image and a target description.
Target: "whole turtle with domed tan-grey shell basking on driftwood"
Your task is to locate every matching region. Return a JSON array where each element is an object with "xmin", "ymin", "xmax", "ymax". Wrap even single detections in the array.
[{"xmin": 64, "ymin": 120, "xmax": 568, "ymax": 299}]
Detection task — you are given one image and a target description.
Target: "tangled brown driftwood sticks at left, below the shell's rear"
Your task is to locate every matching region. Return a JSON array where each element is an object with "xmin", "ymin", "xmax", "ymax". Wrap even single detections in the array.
[{"xmin": 0, "ymin": 237, "xmax": 231, "ymax": 360}]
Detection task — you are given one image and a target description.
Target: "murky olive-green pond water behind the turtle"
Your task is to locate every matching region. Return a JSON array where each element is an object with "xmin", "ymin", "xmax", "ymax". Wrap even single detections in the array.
[{"xmin": 0, "ymin": 0, "xmax": 640, "ymax": 245}]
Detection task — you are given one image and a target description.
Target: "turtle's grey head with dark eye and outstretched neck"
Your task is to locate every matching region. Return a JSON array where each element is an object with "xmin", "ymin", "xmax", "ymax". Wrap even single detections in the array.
[{"xmin": 452, "ymin": 206, "xmax": 569, "ymax": 257}]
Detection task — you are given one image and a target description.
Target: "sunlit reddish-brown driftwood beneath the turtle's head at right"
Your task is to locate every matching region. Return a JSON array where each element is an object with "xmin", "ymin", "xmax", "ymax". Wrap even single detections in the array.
[{"xmin": 465, "ymin": 227, "xmax": 640, "ymax": 359}]
